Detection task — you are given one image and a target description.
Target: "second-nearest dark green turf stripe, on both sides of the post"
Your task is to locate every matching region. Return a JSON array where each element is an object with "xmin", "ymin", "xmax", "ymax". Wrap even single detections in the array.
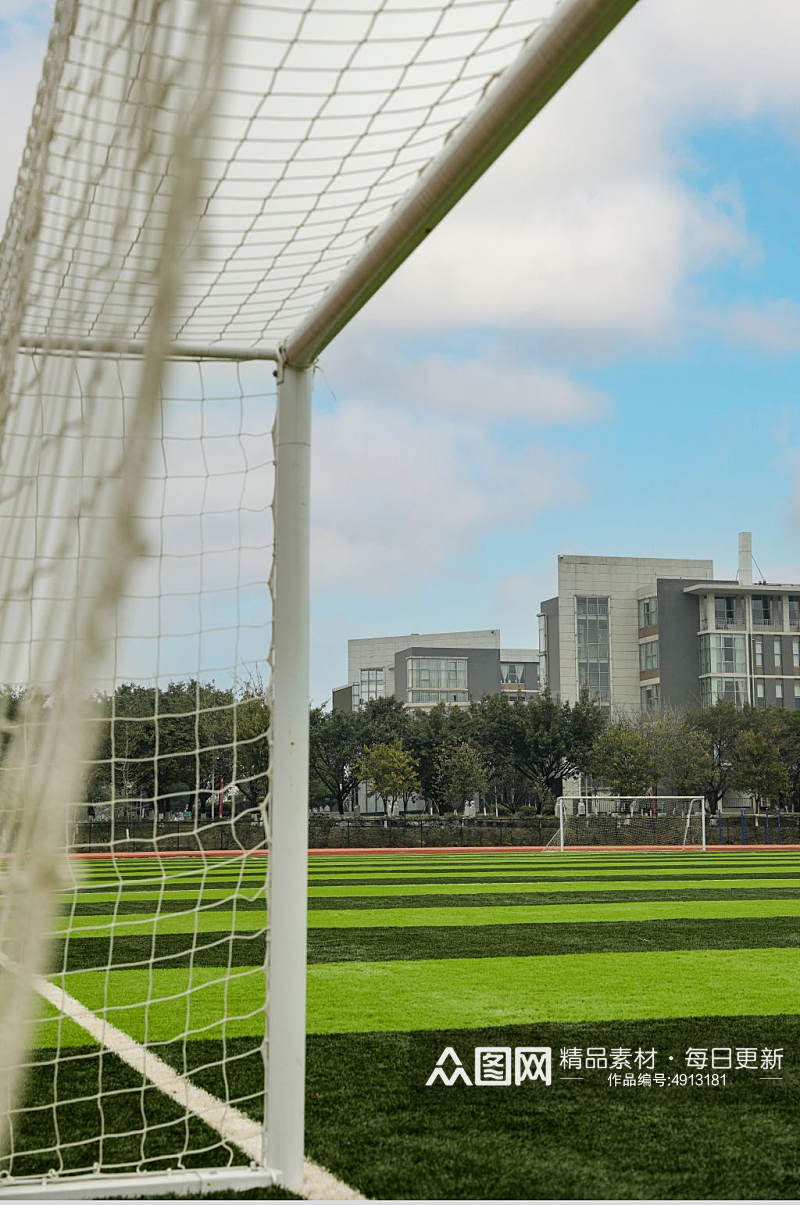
[{"xmin": 51, "ymin": 917, "xmax": 800, "ymax": 971}]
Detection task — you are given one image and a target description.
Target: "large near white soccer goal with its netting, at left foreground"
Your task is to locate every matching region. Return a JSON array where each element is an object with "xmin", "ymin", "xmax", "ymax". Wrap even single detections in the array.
[{"xmin": 0, "ymin": 0, "xmax": 635, "ymax": 1199}]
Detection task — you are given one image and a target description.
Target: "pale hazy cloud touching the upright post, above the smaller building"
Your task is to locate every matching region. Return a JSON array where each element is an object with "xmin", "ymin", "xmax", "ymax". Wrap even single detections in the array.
[{"xmin": 312, "ymin": 402, "xmax": 581, "ymax": 594}]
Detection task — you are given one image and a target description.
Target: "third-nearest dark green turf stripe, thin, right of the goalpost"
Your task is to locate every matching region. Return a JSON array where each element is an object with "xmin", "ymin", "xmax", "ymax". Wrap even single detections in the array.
[{"xmin": 308, "ymin": 887, "xmax": 798, "ymax": 923}]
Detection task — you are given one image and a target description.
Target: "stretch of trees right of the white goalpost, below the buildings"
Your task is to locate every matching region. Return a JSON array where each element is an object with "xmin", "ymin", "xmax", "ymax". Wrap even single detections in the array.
[{"xmin": 311, "ymin": 692, "xmax": 800, "ymax": 813}]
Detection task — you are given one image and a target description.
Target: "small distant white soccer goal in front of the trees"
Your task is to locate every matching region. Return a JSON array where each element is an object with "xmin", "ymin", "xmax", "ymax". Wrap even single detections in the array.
[{"xmin": 543, "ymin": 795, "xmax": 706, "ymax": 851}]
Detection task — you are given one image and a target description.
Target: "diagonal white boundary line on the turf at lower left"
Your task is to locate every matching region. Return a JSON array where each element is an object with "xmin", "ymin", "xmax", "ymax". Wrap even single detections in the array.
[{"xmin": 0, "ymin": 952, "xmax": 365, "ymax": 1200}]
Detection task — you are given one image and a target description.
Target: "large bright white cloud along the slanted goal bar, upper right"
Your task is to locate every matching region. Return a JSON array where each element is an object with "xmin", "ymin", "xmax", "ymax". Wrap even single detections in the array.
[{"xmin": 344, "ymin": 0, "xmax": 800, "ymax": 347}]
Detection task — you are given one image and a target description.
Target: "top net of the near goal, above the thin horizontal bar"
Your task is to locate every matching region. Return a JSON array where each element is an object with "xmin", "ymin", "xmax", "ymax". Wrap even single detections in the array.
[{"xmin": 7, "ymin": 0, "xmax": 554, "ymax": 346}]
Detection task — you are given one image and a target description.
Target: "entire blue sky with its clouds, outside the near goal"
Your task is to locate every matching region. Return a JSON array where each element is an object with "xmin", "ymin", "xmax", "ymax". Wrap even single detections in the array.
[{"xmin": 0, "ymin": 0, "xmax": 800, "ymax": 701}]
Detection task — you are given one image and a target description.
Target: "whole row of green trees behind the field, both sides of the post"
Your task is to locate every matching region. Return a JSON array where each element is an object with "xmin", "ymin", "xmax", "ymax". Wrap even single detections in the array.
[{"xmin": 4, "ymin": 681, "xmax": 800, "ymax": 815}]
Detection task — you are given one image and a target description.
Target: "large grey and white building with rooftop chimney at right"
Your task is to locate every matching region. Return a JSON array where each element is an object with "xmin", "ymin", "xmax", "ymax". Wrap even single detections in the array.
[{"xmin": 539, "ymin": 531, "xmax": 800, "ymax": 715}]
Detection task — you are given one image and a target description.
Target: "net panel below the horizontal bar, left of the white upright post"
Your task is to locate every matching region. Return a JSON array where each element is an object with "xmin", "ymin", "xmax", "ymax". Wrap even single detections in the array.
[{"xmin": 0, "ymin": 357, "xmax": 273, "ymax": 1176}]
